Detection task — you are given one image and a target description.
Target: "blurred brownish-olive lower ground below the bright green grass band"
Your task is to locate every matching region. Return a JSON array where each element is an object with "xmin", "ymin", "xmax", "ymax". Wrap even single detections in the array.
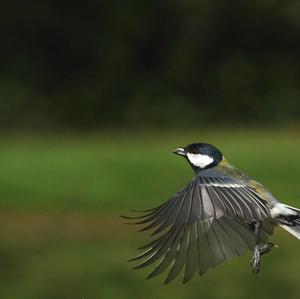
[{"xmin": 0, "ymin": 213, "xmax": 300, "ymax": 299}]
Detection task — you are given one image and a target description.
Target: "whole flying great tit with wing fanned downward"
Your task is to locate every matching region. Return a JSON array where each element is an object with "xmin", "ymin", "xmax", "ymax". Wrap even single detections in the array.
[{"xmin": 124, "ymin": 143, "xmax": 300, "ymax": 283}]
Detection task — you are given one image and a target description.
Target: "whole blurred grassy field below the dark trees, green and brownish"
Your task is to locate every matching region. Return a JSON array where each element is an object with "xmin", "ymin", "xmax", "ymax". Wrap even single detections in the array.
[{"xmin": 0, "ymin": 129, "xmax": 300, "ymax": 299}]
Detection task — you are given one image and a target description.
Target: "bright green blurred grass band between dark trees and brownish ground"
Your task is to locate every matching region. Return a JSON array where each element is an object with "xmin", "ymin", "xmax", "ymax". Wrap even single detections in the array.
[{"xmin": 0, "ymin": 130, "xmax": 300, "ymax": 210}]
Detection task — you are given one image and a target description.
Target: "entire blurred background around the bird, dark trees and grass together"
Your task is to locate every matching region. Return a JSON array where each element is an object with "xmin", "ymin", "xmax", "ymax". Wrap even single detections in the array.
[{"xmin": 0, "ymin": 0, "xmax": 300, "ymax": 299}]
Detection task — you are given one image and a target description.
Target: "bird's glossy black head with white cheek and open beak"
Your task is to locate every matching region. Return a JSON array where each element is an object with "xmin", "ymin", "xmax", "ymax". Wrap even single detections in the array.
[{"xmin": 173, "ymin": 143, "xmax": 224, "ymax": 171}]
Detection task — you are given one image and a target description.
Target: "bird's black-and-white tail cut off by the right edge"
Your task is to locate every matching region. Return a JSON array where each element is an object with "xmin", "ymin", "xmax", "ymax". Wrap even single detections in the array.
[{"xmin": 279, "ymin": 204, "xmax": 300, "ymax": 240}]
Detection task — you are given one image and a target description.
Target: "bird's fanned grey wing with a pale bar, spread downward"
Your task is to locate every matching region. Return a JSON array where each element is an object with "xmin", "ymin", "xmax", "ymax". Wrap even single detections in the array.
[{"xmin": 125, "ymin": 176, "xmax": 273, "ymax": 283}]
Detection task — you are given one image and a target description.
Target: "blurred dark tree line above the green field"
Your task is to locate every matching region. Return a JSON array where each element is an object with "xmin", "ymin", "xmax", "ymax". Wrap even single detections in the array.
[{"xmin": 0, "ymin": 0, "xmax": 300, "ymax": 128}]
